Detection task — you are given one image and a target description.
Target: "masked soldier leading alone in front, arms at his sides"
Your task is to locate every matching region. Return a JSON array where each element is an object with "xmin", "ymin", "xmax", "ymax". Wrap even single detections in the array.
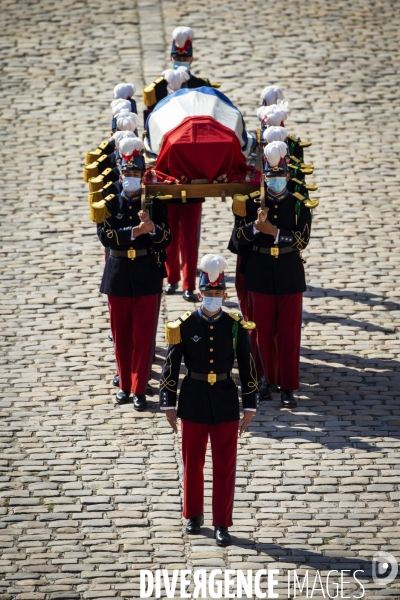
[{"xmin": 160, "ymin": 254, "xmax": 258, "ymax": 546}]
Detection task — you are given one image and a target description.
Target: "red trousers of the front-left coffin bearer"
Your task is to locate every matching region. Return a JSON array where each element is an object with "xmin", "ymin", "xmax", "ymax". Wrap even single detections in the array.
[{"xmin": 108, "ymin": 294, "xmax": 160, "ymax": 394}]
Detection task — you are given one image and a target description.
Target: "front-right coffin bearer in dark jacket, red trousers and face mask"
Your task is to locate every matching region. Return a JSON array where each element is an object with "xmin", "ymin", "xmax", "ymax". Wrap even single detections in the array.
[{"xmin": 235, "ymin": 142, "xmax": 311, "ymax": 408}]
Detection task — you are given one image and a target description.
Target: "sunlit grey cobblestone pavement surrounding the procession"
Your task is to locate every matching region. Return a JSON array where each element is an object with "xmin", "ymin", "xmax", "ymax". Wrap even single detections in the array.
[{"xmin": 0, "ymin": 0, "xmax": 400, "ymax": 600}]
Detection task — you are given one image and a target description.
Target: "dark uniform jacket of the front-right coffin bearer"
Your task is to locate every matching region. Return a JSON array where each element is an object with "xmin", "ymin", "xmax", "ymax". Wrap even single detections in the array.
[{"xmin": 234, "ymin": 190, "xmax": 311, "ymax": 295}]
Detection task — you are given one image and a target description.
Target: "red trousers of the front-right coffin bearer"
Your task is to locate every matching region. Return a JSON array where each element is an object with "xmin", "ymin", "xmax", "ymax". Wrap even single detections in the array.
[{"xmin": 252, "ymin": 292, "xmax": 303, "ymax": 390}]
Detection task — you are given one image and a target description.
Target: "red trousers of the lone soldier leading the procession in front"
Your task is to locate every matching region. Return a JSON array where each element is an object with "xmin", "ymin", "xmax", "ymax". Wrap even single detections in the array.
[{"xmin": 181, "ymin": 419, "xmax": 239, "ymax": 527}]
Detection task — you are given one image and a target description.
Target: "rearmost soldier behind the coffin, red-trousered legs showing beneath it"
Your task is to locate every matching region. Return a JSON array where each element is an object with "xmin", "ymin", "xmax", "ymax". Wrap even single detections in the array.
[{"xmin": 143, "ymin": 27, "xmax": 214, "ymax": 302}]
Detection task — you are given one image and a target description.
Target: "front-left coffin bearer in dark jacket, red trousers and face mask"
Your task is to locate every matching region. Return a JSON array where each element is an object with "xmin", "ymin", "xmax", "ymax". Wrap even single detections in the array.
[{"xmin": 98, "ymin": 152, "xmax": 170, "ymax": 411}]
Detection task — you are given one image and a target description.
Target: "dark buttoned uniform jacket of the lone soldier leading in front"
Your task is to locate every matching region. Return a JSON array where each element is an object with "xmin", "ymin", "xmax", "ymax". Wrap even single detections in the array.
[{"xmin": 160, "ymin": 309, "xmax": 258, "ymax": 424}]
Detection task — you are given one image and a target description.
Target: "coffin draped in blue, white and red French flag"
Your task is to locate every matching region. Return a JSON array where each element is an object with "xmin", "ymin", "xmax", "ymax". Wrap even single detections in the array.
[{"xmin": 146, "ymin": 87, "xmax": 254, "ymax": 182}]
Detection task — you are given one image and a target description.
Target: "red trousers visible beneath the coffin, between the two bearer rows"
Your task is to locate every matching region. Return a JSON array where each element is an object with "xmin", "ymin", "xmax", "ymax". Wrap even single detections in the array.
[{"xmin": 165, "ymin": 203, "xmax": 201, "ymax": 290}]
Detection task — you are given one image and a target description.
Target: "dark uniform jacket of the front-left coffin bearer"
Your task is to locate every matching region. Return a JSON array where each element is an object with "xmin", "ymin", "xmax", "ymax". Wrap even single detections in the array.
[{"xmin": 97, "ymin": 192, "xmax": 170, "ymax": 298}]
